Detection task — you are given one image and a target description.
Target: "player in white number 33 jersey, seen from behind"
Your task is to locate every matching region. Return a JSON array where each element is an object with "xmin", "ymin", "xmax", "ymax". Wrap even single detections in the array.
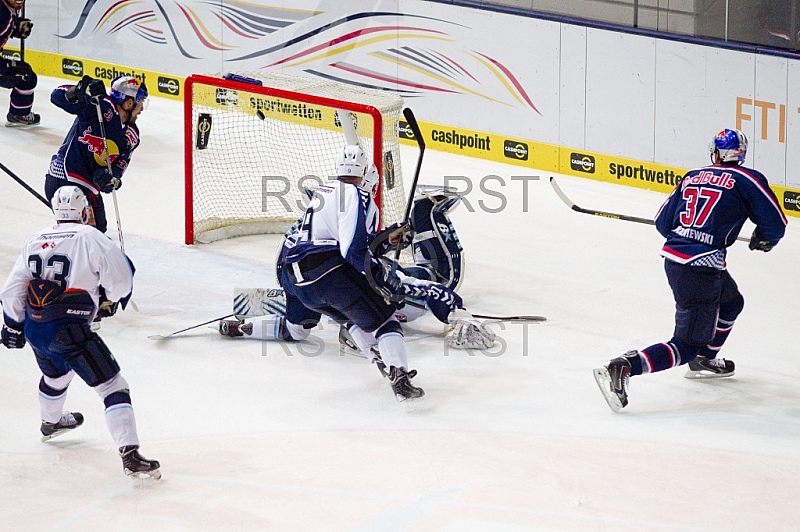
[{"xmin": 0, "ymin": 186, "xmax": 161, "ymax": 478}]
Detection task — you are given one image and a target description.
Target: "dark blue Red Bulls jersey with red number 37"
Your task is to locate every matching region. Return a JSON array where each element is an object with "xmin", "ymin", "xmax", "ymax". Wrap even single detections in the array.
[{"xmin": 656, "ymin": 165, "xmax": 786, "ymax": 270}]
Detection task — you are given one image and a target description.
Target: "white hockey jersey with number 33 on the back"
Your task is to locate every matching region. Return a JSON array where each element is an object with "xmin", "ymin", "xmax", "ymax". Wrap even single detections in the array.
[{"xmin": 0, "ymin": 223, "xmax": 133, "ymax": 322}]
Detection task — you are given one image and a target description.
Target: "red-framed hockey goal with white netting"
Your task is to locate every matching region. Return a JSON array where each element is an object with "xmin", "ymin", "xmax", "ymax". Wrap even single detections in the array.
[{"xmin": 184, "ymin": 72, "xmax": 406, "ymax": 244}]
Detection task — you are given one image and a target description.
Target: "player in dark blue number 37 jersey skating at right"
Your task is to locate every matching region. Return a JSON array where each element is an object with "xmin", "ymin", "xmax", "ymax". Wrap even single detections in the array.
[{"xmin": 594, "ymin": 129, "xmax": 786, "ymax": 412}]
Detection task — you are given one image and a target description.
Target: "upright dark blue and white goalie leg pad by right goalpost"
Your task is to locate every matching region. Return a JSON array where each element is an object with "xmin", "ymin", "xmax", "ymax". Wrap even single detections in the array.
[{"xmin": 411, "ymin": 193, "xmax": 464, "ymax": 290}]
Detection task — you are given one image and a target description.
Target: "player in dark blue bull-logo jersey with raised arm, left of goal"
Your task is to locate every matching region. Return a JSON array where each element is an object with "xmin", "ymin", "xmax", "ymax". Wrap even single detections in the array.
[{"xmin": 44, "ymin": 76, "xmax": 147, "ymax": 233}]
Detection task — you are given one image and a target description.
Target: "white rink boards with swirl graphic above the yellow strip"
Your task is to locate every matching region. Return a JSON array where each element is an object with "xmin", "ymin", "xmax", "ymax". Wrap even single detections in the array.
[{"xmin": 21, "ymin": 0, "xmax": 800, "ymax": 186}]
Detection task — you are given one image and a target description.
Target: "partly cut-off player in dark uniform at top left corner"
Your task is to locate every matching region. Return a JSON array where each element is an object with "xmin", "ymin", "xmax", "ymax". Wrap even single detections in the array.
[{"xmin": 0, "ymin": 0, "xmax": 41, "ymax": 126}]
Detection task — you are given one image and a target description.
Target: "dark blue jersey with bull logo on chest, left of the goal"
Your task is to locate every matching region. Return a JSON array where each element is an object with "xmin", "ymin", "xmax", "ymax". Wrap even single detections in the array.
[{"xmin": 49, "ymin": 85, "xmax": 139, "ymax": 194}]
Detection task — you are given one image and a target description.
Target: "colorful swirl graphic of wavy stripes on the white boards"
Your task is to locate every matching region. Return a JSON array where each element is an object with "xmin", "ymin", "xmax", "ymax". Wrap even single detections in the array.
[{"xmin": 58, "ymin": 0, "xmax": 541, "ymax": 114}]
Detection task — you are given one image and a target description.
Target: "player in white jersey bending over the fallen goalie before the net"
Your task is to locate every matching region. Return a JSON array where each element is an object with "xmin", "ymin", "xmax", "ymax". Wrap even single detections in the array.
[{"xmin": 283, "ymin": 146, "xmax": 425, "ymax": 401}]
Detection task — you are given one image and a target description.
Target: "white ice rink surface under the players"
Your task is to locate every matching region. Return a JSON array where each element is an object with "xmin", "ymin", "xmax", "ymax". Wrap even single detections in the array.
[{"xmin": 0, "ymin": 78, "xmax": 800, "ymax": 532}]
